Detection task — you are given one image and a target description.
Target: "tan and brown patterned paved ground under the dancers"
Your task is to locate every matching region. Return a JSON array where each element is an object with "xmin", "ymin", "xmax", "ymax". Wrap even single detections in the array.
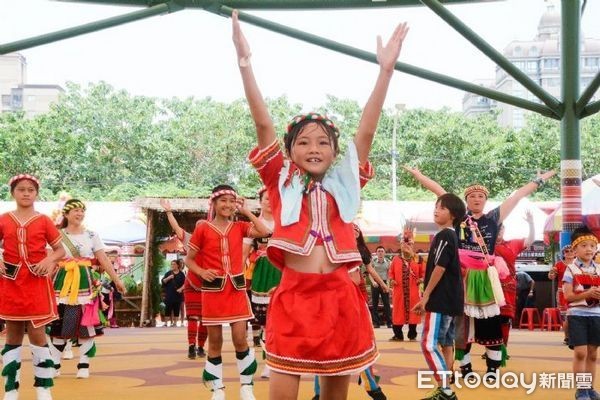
[{"xmin": 0, "ymin": 327, "xmax": 574, "ymax": 400}]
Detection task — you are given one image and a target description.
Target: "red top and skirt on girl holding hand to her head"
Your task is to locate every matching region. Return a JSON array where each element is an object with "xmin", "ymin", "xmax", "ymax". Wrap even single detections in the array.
[{"xmin": 189, "ymin": 221, "xmax": 254, "ymax": 326}]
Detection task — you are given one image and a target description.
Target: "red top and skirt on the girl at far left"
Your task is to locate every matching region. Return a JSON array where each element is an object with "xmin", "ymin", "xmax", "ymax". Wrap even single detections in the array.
[{"xmin": 0, "ymin": 212, "xmax": 61, "ymax": 328}]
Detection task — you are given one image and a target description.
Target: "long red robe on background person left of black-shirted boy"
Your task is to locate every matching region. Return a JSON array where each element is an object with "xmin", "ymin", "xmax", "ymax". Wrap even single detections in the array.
[{"xmin": 388, "ymin": 256, "xmax": 423, "ymax": 325}]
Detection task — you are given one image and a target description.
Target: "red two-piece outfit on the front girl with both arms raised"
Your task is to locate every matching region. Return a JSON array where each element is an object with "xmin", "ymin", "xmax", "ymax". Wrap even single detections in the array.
[{"xmin": 250, "ymin": 142, "xmax": 379, "ymax": 375}]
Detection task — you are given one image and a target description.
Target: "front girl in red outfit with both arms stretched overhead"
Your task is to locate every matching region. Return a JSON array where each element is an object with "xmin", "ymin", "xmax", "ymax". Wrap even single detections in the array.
[{"xmin": 232, "ymin": 11, "xmax": 408, "ymax": 400}]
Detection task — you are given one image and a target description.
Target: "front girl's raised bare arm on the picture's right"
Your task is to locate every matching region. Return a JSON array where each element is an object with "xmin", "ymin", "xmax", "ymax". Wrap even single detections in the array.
[{"xmin": 354, "ymin": 23, "xmax": 408, "ymax": 164}]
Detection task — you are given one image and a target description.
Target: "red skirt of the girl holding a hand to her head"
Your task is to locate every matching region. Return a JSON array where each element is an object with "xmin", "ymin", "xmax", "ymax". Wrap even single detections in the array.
[{"xmin": 202, "ymin": 276, "xmax": 254, "ymax": 326}]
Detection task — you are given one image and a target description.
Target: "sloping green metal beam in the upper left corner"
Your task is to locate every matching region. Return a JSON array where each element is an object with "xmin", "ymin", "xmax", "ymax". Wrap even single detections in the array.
[{"xmin": 0, "ymin": 2, "xmax": 183, "ymax": 54}]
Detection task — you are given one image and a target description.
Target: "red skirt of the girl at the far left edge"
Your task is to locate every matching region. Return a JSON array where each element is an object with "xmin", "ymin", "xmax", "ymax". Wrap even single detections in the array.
[{"xmin": 0, "ymin": 265, "xmax": 58, "ymax": 328}]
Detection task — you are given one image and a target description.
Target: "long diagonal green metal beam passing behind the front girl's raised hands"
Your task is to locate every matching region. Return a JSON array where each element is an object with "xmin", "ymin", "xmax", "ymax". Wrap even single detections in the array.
[{"xmin": 218, "ymin": 6, "xmax": 560, "ymax": 119}]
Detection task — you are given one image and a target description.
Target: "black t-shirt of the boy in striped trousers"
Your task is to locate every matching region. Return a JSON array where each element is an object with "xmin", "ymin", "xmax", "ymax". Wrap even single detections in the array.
[{"xmin": 425, "ymin": 228, "xmax": 464, "ymax": 316}]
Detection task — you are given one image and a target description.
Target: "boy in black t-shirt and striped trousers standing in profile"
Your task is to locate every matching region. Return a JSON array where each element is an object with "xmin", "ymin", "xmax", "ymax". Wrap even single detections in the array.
[{"xmin": 413, "ymin": 193, "xmax": 466, "ymax": 400}]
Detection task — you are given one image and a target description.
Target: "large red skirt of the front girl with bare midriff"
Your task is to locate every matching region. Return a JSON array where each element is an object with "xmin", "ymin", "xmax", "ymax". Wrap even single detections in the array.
[{"xmin": 265, "ymin": 267, "xmax": 379, "ymax": 375}]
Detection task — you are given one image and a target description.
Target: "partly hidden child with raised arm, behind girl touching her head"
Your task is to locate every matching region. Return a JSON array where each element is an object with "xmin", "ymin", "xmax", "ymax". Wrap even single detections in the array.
[{"xmin": 160, "ymin": 199, "xmax": 208, "ymax": 360}]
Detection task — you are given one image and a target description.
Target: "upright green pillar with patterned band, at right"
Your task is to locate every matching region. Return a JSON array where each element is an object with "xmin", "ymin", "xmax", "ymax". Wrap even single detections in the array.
[{"xmin": 560, "ymin": 0, "xmax": 582, "ymax": 248}]
